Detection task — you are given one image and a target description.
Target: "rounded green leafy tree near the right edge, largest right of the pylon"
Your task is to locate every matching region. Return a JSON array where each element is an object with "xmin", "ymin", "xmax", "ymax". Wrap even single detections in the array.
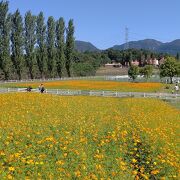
[{"xmin": 160, "ymin": 57, "xmax": 179, "ymax": 83}]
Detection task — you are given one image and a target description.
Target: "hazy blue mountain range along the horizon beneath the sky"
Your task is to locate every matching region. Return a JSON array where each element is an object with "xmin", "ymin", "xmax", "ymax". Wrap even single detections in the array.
[{"xmin": 75, "ymin": 39, "xmax": 180, "ymax": 55}]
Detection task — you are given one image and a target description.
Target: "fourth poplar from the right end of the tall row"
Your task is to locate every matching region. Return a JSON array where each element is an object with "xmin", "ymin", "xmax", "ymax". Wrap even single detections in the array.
[{"xmin": 36, "ymin": 12, "xmax": 46, "ymax": 78}]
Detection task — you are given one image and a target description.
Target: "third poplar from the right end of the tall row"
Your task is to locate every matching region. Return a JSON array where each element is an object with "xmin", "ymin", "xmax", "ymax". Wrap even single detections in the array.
[{"xmin": 47, "ymin": 16, "xmax": 55, "ymax": 77}]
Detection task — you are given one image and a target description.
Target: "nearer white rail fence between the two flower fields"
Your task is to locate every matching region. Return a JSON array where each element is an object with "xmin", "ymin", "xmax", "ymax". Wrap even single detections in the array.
[{"xmin": 0, "ymin": 88, "xmax": 180, "ymax": 100}]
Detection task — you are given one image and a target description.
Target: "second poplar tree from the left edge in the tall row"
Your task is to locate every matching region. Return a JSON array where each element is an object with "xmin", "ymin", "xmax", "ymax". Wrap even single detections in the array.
[{"xmin": 11, "ymin": 10, "xmax": 24, "ymax": 80}]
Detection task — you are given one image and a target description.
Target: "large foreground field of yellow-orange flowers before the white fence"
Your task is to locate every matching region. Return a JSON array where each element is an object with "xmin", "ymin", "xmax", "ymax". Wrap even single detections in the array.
[{"xmin": 0, "ymin": 93, "xmax": 180, "ymax": 179}]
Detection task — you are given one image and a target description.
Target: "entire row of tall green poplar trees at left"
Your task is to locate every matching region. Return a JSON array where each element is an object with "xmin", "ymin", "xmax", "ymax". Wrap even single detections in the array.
[{"xmin": 0, "ymin": 1, "xmax": 74, "ymax": 79}]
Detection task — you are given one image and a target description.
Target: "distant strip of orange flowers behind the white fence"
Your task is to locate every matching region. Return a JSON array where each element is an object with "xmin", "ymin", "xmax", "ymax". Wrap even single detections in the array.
[{"xmin": 2, "ymin": 80, "xmax": 163, "ymax": 92}]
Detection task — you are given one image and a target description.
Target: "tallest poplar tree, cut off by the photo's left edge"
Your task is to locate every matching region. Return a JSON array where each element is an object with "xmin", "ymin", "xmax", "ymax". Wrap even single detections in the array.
[{"xmin": 0, "ymin": 1, "xmax": 11, "ymax": 80}]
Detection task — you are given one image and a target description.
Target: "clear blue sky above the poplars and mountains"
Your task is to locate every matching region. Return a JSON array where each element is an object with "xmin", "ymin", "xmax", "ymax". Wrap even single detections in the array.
[{"xmin": 9, "ymin": 0, "xmax": 180, "ymax": 49}]
